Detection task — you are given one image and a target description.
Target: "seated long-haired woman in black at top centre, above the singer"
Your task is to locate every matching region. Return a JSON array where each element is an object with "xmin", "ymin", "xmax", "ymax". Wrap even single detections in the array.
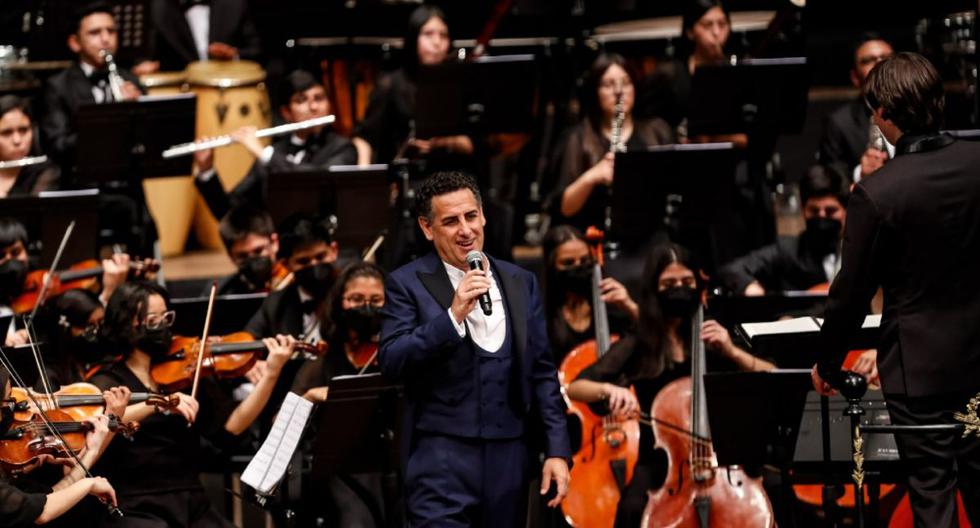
[{"xmin": 354, "ymin": 5, "xmax": 474, "ymax": 164}]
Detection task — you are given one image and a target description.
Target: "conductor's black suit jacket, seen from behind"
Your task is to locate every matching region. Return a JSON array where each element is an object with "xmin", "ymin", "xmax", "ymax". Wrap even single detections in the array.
[{"xmin": 819, "ymin": 136, "xmax": 980, "ymax": 397}]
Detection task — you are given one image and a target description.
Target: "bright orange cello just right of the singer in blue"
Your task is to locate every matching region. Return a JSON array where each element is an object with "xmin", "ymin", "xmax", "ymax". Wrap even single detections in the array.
[{"xmin": 558, "ymin": 227, "xmax": 640, "ymax": 528}]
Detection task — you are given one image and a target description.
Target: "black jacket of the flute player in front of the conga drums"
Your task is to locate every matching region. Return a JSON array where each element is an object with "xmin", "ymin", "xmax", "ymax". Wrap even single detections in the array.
[{"xmin": 194, "ymin": 130, "xmax": 357, "ymax": 218}]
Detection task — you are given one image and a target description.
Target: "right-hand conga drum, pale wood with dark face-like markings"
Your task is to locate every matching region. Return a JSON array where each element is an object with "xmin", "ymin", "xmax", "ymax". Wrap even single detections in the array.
[{"xmin": 186, "ymin": 61, "xmax": 272, "ymax": 249}]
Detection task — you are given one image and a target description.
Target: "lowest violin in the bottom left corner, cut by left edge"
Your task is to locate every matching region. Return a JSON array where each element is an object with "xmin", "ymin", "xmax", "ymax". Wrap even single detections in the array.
[{"xmin": 0, "ymin": 409, "xmax": 139, "ymax": 473}]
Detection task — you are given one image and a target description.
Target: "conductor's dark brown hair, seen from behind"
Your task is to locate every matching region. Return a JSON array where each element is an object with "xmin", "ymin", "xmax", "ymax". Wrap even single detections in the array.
[{"xmin": 864, "ymin": 52, "xmax": 946, "ymax": 134}]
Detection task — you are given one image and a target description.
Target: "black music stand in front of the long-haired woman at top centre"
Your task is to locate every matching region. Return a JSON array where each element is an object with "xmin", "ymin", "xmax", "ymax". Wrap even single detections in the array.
[{"xmin": 415, "ymin": 55, "xmax": 538, "ymax": 138}]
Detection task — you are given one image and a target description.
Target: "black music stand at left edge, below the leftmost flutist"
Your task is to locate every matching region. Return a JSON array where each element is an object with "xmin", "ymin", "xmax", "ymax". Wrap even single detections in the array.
[{"xmin": 0, "ymin": 189, "xmax": 99, "ymax": 268}]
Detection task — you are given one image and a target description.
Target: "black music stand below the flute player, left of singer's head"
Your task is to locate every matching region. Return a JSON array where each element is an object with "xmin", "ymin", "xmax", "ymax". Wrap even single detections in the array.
[{"xmin": 267, "ymin": 165, "xmax": 391, "ymax": 253}]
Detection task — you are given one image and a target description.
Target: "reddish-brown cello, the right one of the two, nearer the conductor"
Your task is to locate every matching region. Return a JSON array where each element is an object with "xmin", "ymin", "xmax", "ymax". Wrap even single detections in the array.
[{"xmin": 640, "ymin": 307, "xmax": 775, "ymax": 528}]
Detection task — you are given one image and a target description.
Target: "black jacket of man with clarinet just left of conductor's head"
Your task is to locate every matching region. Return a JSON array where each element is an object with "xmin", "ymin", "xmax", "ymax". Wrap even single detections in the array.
[{"xmin": 817, "ymin": 101, "xmax": 871, "ymax": 181}]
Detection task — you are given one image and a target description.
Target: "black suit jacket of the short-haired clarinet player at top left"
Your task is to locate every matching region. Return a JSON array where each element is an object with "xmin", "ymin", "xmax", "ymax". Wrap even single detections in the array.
[{"xmin": 41, "ymin": 62, "xmax": 140, "ymax": 168}]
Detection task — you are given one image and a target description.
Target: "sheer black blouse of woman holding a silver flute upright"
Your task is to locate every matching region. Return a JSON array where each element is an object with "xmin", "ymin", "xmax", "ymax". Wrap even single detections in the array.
[{"xmin": 546, "ymin": 118, "xmax": 674, "ymax": 232}]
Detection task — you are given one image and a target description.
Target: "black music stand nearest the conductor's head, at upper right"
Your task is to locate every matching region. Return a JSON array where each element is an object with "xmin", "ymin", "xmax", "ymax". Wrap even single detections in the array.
[{"xmin": 687, "ymin": 57, "xmax": 810, "ymax": 136}]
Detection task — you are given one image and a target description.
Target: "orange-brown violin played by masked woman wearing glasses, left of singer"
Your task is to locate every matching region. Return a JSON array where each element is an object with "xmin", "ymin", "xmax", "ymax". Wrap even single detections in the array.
[{"xmin": 150, "ymin": 332, "xmax": 326, "ymax": 392}]
